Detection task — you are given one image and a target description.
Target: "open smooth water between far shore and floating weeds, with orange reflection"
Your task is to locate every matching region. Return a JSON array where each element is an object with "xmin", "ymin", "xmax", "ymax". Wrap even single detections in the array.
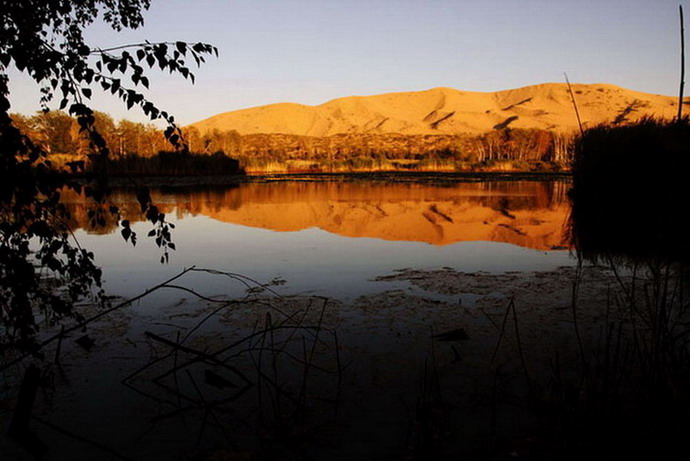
[{"xmin": 64, "ymin": 181, "xmax": 573, "ymax": 298}]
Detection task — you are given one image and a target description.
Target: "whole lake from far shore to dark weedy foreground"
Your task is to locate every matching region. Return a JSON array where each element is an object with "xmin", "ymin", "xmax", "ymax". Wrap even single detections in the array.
[{"xmin": 8, "ymin": 175, "xmax": 644, "ymax": 460}]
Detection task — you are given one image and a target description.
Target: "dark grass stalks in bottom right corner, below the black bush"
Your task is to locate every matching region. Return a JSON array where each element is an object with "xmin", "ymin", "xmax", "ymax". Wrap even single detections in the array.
[{"xmin": 541, "ymin": 261, "xmax": 690, "ymax": 459}]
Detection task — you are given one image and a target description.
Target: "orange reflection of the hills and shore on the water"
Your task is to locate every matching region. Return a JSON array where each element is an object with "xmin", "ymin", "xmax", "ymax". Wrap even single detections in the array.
[{"xmin": 63, "ymin": 181, "xmax": 570, "ymax": 250}]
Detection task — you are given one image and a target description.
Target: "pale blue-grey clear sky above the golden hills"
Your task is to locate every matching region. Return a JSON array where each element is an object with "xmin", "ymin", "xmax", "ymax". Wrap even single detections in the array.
[{"xmin": 4, "ymin": 0, "xmax": 690, "ymax": 124}]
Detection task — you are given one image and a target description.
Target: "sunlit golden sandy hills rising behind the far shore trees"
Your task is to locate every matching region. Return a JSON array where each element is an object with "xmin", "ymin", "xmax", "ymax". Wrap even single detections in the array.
[{"xmin": 192, "ymin": 83, "xmax": 690, "ymax": 136}]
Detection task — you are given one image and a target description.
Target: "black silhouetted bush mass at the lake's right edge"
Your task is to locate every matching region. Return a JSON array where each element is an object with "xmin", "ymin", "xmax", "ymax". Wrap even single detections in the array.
[{"xmin": 570, "ymin": 117, "xmax": 690, "ymax": 261}]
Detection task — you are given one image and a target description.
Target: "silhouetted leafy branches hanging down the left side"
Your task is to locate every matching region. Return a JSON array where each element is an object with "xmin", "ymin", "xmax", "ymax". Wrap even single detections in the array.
[{"xmin": 0, "ymin": 0, "xmax": 217, "ymax": 353}]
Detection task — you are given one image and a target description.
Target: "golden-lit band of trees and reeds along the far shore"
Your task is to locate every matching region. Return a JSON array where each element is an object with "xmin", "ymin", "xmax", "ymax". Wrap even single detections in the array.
[{"xmin": 13, "ymin": 111, "xmax": 688, "ymax": 178}]
